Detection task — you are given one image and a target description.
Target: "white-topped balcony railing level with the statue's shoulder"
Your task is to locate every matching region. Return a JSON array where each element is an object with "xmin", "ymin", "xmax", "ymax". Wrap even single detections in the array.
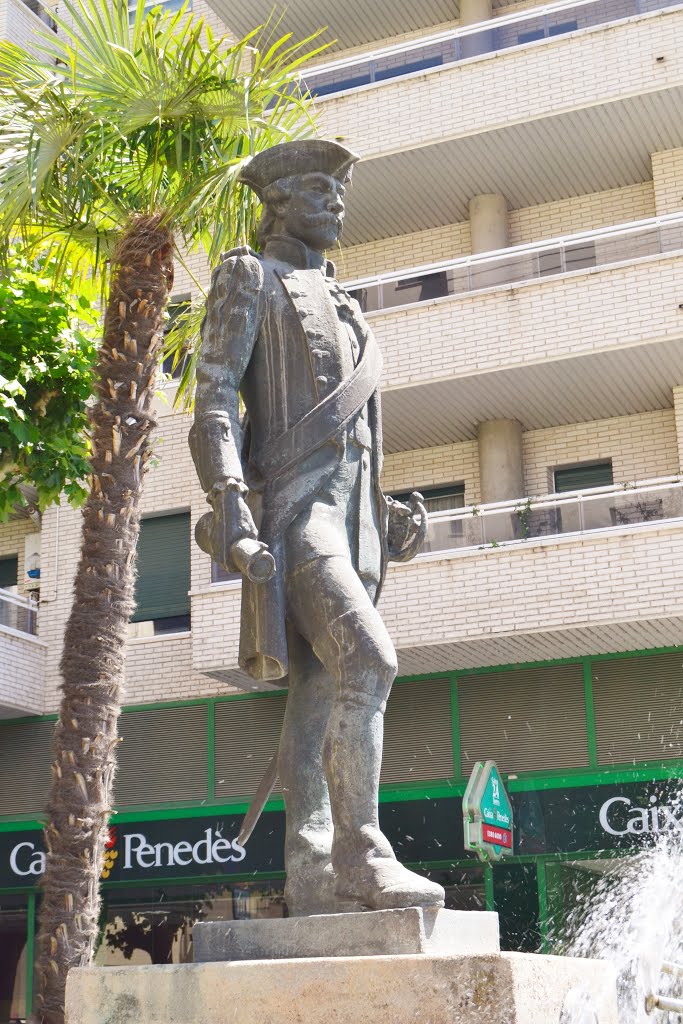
[{"xmin": 344, "ymin": 213, "xmax": 683, "ymax": 312}]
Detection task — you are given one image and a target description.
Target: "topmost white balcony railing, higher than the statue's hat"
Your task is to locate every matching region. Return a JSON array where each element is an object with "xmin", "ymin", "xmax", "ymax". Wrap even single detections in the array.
[{"xmin": 303, "ymin": 0, "xmax": 681, "ymax": 96}]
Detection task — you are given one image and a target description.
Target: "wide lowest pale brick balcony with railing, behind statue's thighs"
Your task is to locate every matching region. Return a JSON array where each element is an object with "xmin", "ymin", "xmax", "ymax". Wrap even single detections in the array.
[{"xmin": 193, "ymin": 477, "xmax": 683, "ymax": 687}]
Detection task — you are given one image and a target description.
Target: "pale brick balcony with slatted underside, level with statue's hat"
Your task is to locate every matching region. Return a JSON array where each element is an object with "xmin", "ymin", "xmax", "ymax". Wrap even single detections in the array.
[{"xmin": 318, "ymin": 3, "xmax": 683, "ymax": 246}]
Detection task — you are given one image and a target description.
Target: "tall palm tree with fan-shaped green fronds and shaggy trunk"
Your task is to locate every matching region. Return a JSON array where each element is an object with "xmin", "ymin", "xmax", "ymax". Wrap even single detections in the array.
[{"xmin": 0, "ymin": 0, "xmax": 317, "ymax": 1024}]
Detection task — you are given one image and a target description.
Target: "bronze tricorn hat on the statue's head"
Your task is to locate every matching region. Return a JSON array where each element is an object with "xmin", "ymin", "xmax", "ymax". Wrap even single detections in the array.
[{"xmin": 239, "ymin": 138, "xmax": 359, "ymax": 199}]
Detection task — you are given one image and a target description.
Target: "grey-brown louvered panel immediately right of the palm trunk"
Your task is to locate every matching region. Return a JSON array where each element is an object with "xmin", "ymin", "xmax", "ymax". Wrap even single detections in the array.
[{"xmin": 114, "ymin": 705, "xmax": 208, "ymax": 807}]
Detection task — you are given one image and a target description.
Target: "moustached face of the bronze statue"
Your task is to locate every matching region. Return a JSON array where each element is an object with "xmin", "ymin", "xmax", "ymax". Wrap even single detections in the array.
[{"xmin": 281, "ymin": 173, "xmax": 344, "ymax": 252}]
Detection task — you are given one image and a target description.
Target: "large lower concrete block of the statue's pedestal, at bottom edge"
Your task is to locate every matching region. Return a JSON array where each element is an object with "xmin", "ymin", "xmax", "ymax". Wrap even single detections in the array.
[{"xmin": 67, "ymin": 953, "xmax": 617, "ymax": 1024}]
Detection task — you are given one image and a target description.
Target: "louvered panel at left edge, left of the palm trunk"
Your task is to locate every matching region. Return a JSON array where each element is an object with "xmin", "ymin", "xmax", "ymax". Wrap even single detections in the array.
[{"xmin": 0, "ymin": 721, "xmax": 54, "ymax": 814}]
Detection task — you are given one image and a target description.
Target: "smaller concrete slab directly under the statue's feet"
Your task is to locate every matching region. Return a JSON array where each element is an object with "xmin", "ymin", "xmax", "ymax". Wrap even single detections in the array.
[{"xmin": 193, "ymin": 906, "xmax": 501, "ymax": 964}]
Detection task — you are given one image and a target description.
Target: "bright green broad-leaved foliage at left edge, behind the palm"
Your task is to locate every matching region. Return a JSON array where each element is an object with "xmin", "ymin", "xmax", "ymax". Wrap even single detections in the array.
[{"xmin": 0, "ymin": 251, "xmax": 96, "ymax": 521}]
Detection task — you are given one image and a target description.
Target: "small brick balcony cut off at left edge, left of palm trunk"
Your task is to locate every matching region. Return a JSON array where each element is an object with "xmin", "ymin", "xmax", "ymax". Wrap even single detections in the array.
[{"xmin": 0, "ymin": 590, "xmax": 47, "ymax": 718}]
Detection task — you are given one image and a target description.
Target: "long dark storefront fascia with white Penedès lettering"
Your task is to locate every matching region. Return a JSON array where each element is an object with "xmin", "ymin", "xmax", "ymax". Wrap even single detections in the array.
[{"xmin": 0, "ymin": 780, "xmax": 683, "ymax": 890}]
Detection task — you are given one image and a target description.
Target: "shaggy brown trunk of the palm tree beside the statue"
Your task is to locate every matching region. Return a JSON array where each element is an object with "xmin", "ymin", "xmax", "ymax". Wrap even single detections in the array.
[{"xmin": 34, "ymin": 216, "xmax": 173, "ymax": 1024}]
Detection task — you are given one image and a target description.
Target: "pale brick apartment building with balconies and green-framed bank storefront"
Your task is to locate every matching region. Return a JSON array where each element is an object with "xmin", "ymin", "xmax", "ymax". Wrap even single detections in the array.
[{"xmin": 0, "ymin": 0, "xmax": 683, "ymax": 1007}]
